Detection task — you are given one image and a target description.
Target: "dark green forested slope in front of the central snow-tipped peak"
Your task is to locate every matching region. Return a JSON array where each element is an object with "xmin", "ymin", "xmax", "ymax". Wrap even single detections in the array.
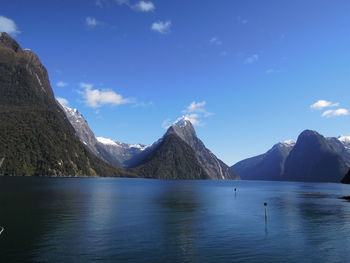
[{"xmin": 133, "ymin": 134, "xmax": 209, "ymax": 179}]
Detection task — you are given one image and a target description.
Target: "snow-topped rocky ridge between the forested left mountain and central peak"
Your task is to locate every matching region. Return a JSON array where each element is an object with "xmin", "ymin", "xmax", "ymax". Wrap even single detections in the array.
[{"xmin": 62, "ymin": 105, "xmax": 155, "ymax": 168}]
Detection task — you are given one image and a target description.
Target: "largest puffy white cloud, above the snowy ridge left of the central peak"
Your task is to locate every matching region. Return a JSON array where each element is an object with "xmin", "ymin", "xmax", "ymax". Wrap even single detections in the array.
[{"xmin": 80, "ymin": 83, "xmax": 132, "ymax": 108}]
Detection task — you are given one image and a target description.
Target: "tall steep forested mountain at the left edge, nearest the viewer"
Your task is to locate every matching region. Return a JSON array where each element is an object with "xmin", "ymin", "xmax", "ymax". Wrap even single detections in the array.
[{"xmin": 0, "ymin": 33, "xmax": 135, "ymax": 176}]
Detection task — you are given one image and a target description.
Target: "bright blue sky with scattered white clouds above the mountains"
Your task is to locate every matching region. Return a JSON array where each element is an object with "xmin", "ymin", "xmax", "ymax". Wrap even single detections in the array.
[{"xmin": 0, "ymin": 0, "xmax": 350, "ymax": 165}]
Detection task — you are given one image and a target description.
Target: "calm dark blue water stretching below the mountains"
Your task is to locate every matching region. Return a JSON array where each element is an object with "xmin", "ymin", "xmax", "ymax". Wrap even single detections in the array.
[{"xmin": 0, "ymin": 178, "xmax": 350, "ymax": 262}]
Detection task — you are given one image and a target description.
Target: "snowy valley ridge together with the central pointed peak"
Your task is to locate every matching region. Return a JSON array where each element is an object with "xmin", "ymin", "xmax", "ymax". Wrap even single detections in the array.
[{"xmin": 62, "ymin": 102, "xmax": 240, "ymax": 180}]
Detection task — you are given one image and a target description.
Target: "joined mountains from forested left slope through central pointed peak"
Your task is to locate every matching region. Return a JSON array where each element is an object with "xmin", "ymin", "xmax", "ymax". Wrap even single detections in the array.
[{"xmin": 0, "ymin": 33, "xmax": 239, "ymax": 179}]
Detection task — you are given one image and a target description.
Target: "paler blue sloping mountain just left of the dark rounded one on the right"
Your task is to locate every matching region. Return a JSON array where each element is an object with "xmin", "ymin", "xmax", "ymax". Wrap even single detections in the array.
[{"xmin": 232, "ymin": 140, "xmax": 295, "ymax": 181}]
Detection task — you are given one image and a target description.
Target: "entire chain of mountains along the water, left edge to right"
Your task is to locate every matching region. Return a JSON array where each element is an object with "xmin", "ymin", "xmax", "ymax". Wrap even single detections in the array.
[{"xmin": 0, "ymin": 33, "xmax": 350, "ymax": 183}]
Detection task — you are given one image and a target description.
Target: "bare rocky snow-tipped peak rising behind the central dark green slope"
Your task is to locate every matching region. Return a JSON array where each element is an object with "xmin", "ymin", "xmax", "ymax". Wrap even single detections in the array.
[{"xmin": 165, "ymin": 117, "xmax": 240, "ymax": 182}]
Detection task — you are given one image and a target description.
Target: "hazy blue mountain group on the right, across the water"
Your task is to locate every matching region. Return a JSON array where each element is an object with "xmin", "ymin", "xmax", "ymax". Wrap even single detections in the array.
[{"xmin": 232, "ymin": 130, "xmax": 350, "ymax": 182}]
